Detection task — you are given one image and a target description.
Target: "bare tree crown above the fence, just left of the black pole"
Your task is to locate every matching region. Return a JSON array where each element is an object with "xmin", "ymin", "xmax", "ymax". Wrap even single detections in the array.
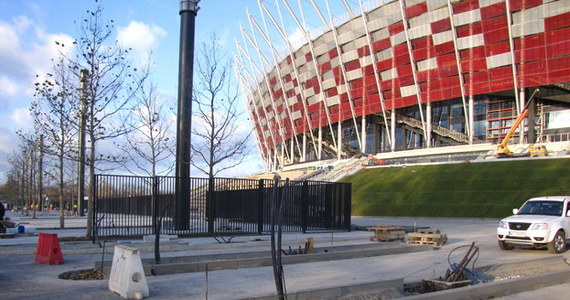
[{"xmin": 120, "ymin": 77, "xmax": 176, "ymax": 177}]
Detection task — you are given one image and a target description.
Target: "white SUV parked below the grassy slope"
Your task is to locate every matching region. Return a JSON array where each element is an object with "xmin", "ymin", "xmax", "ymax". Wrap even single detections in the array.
[{"xmin": 497, "ymin": 196, "xmax": 570, "ymax": 253}]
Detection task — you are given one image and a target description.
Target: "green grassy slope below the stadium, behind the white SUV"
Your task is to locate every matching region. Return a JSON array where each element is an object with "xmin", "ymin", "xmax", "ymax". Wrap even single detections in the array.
[{"xmin": 342, "ymin": 159, "xmax": 570, "ymax": 218}]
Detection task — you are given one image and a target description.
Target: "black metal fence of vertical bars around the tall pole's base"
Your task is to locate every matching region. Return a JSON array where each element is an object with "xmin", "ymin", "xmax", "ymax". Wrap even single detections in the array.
[{"xmin": 93, "ymin": 175, "xmax": 351, "ymax": 238}]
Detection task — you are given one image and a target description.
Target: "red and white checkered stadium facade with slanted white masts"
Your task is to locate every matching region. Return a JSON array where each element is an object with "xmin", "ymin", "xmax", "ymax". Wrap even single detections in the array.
[{"xmin": 235, "ymin": 0, "xmax": 570, "ymax": 170}]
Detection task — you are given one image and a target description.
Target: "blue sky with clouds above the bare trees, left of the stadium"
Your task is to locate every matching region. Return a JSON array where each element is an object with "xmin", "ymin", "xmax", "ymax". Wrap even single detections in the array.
[{"xmin": 0, "ymin": 0, "xmax": 262, "ymax": 183}]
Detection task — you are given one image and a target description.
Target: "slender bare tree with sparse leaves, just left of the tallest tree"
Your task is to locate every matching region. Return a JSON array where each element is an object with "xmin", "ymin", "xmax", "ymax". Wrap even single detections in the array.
[{"xmin": 30, "ymin": 58, "xmax": 78, "ymax": 228}]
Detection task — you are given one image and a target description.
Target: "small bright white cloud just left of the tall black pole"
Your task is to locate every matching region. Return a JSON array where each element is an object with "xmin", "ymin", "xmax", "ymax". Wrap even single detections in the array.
[{"xmin": 117, "ymin": 21, "xmax": 166, "ymax": 62}]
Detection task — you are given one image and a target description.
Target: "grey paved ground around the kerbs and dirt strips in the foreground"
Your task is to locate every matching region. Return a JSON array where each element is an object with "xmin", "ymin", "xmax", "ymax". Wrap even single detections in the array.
[{"xmin": 0, "ymin": 212, "xmax": 570, "ymax": 300}]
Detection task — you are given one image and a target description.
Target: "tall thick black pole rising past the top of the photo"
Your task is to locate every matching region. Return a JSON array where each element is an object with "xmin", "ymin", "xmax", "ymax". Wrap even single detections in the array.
[{"xmin": 174, "ymin": 0, "xmax": 199, "ymax": 230}]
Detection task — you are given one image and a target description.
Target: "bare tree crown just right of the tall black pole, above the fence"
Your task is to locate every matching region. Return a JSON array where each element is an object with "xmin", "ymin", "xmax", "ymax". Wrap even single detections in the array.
[{"xmin": 191, "ymin": 34, "xmax": 251, "ymax": 179}]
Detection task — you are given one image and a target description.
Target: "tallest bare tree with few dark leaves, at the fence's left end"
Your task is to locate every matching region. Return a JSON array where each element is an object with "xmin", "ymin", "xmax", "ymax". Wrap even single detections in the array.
[{"xmin": 58, "ymin": 4, "xmax": 147, "ymax": 237}]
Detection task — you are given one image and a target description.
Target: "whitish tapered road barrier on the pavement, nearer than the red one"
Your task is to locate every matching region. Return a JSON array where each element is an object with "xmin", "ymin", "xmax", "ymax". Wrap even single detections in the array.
[{"xmin": 109, "ymin": 245, "xmax": 149, "ymax": 299}]
